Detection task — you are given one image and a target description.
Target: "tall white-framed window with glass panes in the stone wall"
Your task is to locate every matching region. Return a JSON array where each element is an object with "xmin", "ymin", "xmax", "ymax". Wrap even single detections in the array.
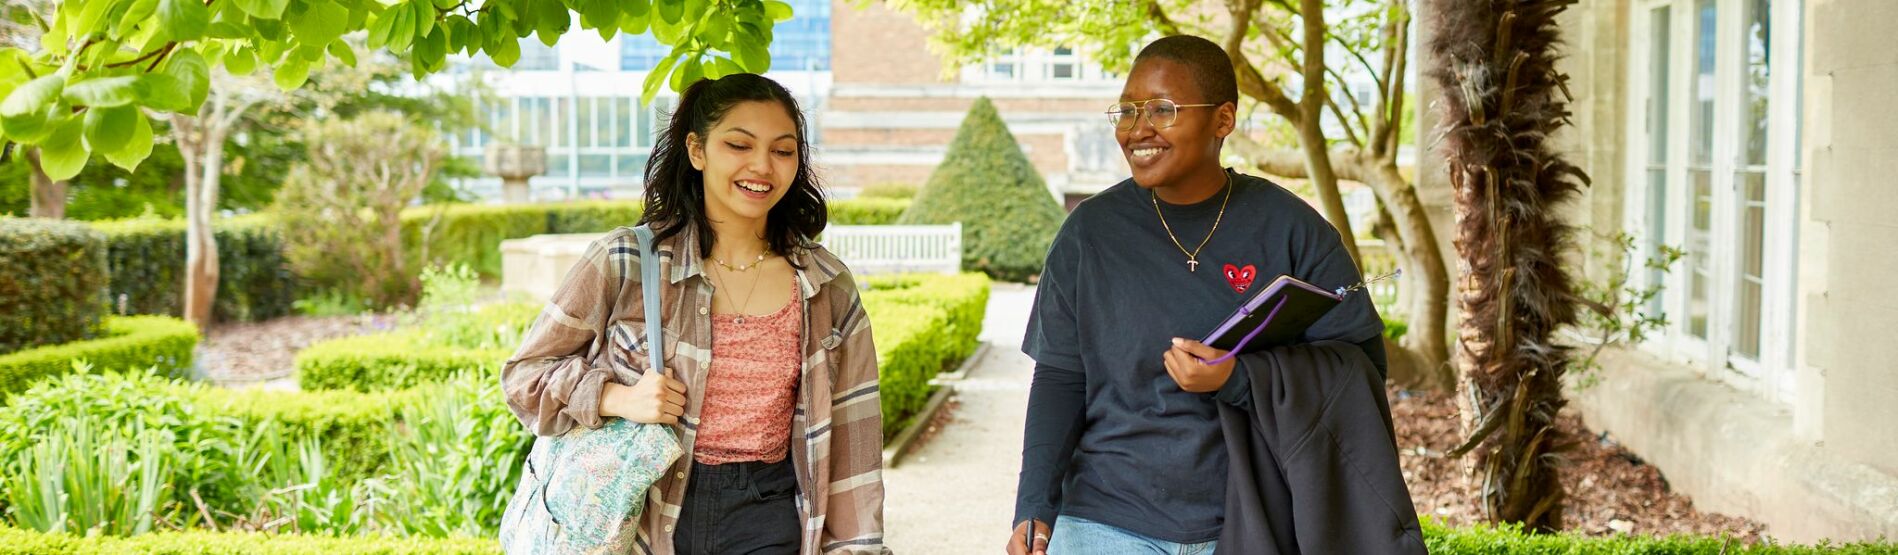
[{"xmin": 1627, "ymin": 0, "xmax": 1801, "ymax": 397}]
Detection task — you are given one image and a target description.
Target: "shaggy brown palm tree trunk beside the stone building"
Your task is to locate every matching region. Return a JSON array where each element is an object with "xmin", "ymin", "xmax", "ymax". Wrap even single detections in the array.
[{"xmin": 1425, "ymin": 0, "xmax": 1587, "ymax": 530}]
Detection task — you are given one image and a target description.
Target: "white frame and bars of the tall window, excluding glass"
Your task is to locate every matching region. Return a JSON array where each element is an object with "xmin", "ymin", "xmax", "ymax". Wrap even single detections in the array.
[{"xmin": 1623, "ymin": 0, "xmax": 1803, "ymax": 403}]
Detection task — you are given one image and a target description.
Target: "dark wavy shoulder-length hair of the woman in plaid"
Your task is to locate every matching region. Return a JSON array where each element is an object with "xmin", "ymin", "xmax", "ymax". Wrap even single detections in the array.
[{"xmin": 640, "ymin": 74, "xmax": 829, "ymax": 264}]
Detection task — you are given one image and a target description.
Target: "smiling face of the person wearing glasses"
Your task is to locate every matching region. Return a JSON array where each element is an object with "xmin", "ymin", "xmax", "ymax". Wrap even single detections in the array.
[{"xmin": 1114, "ymin": 57, "xmax": 1234, "ymax": 188}]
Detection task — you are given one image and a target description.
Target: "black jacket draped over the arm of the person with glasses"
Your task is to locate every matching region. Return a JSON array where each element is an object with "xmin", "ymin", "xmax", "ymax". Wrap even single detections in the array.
[{"xmin": 1219, "ymin": 340, "xmax": 1425, "ymax": 555}]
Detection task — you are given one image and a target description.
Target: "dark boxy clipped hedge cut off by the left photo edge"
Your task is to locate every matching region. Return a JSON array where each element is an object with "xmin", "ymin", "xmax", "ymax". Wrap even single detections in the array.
[{"xmin": 0, "ymin": 219, "xmax": 108, "ymax": 354}]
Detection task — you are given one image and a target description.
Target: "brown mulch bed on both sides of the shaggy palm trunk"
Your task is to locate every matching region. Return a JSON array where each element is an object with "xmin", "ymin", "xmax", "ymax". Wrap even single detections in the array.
[{"xmin": 1389, "ymin": 390, "xmax": 1767, "ymax": 544}]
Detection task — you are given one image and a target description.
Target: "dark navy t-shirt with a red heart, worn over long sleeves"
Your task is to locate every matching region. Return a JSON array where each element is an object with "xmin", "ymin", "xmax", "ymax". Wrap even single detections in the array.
[{"xmin": 1015, "ymin": 173, "xmax": 1384, "ymax": 544}]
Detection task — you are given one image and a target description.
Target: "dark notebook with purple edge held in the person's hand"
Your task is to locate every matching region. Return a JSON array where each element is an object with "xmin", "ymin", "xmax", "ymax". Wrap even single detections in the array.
[{"xmin": 1200, "ymin": 276, "xmax": 1344, "ymax": 363}]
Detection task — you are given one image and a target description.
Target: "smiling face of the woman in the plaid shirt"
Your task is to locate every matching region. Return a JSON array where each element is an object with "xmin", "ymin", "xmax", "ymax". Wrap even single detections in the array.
[{"xmin": 685, "ymin": 101, "xmax": 797, "ymax": 224}]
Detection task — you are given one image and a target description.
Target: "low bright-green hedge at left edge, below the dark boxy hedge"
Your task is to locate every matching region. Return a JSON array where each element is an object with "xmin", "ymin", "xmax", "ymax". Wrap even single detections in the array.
[{"xmin": 0, "ymin": 316, "xmax": 197, "ymax": 393}]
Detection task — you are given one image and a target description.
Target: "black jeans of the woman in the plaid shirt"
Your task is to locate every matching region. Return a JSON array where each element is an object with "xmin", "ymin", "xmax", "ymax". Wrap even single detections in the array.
[{"xmin": 672, "ymin": 456, "xmax": 803, "ymax": 555}]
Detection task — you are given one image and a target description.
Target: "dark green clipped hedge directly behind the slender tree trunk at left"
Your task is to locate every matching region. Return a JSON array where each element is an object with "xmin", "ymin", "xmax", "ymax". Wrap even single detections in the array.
[{"xmin": 91, "ymin": 215, "xmax": 298, "ymax": 321}]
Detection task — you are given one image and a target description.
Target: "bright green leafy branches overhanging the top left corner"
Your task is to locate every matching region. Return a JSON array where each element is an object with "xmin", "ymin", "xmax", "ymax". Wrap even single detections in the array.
[{"xmin": 0, "ymin": 0, "xmax": 791, "ymax": 179}]
